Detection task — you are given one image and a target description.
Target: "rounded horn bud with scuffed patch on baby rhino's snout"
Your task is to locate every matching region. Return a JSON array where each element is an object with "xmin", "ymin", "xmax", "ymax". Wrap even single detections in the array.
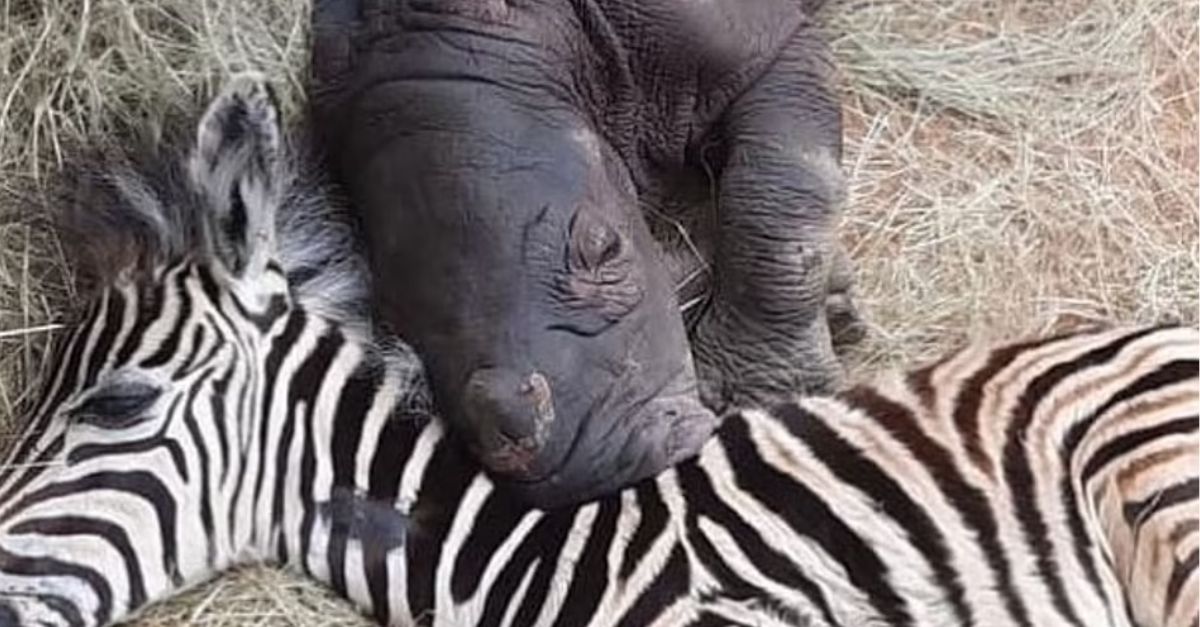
[{"xmin": 463, "ymin": 368, "xmax": 554, "ymax": 478}]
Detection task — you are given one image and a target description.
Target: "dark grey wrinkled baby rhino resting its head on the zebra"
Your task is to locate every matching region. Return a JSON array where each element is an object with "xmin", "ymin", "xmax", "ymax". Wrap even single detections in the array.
[{"xmin": 312, "ymin": 0, "xmax": 857, "ymax": 504}]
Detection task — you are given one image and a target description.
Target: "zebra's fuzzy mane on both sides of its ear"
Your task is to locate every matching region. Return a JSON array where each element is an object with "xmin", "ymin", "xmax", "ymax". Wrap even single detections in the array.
[{"xmin": 52, "ymin": 119, "xmax": 426, "ymax": 386}]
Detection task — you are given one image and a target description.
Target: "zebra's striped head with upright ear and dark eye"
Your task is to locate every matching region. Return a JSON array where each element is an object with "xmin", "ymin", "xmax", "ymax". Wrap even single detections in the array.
[{"xmin": 0, "ymin": 77, "xmax": 311, "ymax": 626}]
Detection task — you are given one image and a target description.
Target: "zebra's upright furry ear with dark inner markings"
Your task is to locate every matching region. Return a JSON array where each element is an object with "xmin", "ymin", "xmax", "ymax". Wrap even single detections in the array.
[{"xmin": 188, "ymin": 73, "xmax": 283, "ymax": 277}]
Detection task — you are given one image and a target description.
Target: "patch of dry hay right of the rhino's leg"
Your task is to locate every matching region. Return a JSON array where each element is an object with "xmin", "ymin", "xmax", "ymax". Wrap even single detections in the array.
[{"xmin": 834, "ymin": 0, "xmax": 1200, "ymax": 370}]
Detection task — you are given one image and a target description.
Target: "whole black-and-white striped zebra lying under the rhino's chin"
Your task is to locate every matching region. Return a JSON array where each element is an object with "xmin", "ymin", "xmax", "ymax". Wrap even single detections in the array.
[{"xmin": 0, "ymin": 79, "xmax": 1200, "ymax": 627}]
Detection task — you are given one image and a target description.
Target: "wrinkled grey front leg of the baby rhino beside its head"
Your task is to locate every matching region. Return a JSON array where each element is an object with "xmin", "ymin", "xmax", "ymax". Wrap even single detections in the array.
[{"xmin": 694, "ymin": 21, "xmax": 862, "ymax": 408}]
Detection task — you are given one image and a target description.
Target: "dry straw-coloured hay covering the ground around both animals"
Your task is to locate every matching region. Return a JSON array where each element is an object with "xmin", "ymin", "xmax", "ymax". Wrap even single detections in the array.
[{"xmin": 0, "ymin": 0, "xmax": 1200, "ymax": 626}]
